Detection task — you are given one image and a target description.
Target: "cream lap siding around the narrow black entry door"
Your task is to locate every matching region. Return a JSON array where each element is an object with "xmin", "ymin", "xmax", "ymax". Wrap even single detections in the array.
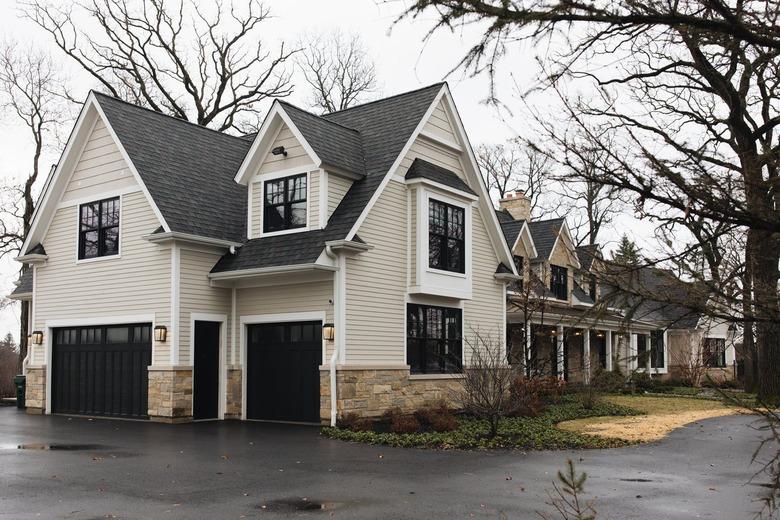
[{"xmin": 179, "ymin": 248, "xmax": 233, "ymax": 365}]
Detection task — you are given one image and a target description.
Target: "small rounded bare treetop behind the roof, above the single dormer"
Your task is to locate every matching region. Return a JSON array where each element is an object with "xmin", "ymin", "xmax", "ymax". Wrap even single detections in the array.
[{"xmin": 296, "ymin": 30, "xmax": 378, "ymax": 113}]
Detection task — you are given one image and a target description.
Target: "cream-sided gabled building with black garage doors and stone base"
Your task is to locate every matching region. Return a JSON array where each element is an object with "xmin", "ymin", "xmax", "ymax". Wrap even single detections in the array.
[{"xmin": 13, "ymin": 84, "xmax": 518, "ymax": 422}]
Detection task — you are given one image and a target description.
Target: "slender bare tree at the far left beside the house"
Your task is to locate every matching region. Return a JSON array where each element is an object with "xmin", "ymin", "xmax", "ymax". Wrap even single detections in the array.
[{"xmin": 0, "ymin": 42, "xmax": 72, "ymax": 374}]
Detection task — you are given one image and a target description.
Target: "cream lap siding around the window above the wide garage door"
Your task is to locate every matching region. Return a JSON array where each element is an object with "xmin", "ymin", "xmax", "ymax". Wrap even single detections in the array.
[{"xmin": 32, "ymin": 191, "xmax": 171, "ymax": 364}]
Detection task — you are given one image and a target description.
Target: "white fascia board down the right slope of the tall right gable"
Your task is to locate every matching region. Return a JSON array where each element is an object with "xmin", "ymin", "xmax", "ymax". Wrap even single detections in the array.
[{"xmin": 438, "ymin": 84, "xmax": 517, "ymax": 274}]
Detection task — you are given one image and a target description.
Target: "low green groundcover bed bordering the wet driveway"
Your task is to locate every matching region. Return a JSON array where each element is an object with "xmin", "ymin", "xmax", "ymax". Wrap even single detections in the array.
[{"xmin": 322, "ymin": 396, "xmax": 641, "ymax": 450}]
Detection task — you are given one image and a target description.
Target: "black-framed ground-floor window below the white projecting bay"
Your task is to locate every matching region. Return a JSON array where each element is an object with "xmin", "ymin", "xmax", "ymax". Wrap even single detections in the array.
[{"xmin": 406, "ymin": 304, "xmax": 463, "ymax": 374}]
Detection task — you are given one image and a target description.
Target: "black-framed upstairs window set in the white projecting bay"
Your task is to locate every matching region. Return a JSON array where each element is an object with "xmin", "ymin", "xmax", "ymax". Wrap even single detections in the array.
[{"xmin": 428, "ymin": 199, "xmax": 466, "ymax": 273}]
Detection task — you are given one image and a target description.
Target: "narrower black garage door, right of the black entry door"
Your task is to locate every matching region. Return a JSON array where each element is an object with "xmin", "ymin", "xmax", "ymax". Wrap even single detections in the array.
[{"xmin": 246, "ymin": 321, "xmax": 322, "ymax": 422}]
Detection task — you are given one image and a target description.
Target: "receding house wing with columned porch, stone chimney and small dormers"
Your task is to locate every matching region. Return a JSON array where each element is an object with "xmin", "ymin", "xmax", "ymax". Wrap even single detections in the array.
[{"xmin": 497, "ymin": 192, "xmax": 734, "ymax": 382}]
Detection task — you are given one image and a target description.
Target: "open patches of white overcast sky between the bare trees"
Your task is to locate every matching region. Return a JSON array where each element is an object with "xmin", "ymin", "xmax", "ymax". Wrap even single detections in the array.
[{"xmin": 0, "ymin": 0, "xmax": 652, "ymax": 342}]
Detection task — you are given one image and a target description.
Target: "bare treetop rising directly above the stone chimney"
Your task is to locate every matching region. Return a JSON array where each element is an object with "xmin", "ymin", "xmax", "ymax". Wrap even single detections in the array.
[{"xmin": 476, "ymin": 139, "xmax": 552, "ymax": 211}]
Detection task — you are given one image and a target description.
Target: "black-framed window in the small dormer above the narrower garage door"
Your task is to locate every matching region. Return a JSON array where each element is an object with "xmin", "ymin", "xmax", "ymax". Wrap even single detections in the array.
[{"xmin": 263, "ymin": 173, "xmax": 306, "ymax": 233}]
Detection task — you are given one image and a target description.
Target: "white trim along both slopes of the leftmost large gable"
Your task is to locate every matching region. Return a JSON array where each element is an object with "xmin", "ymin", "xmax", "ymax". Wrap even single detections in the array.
[{"xmin": 21, "ymin": 92, "xmax": 171, "ymax": 254}]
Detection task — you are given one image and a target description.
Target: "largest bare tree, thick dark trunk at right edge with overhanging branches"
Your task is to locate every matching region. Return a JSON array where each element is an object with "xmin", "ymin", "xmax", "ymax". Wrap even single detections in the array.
[{"xmin": 396, "ymin": 0, "xmax": 780, "ymax": 402}]
